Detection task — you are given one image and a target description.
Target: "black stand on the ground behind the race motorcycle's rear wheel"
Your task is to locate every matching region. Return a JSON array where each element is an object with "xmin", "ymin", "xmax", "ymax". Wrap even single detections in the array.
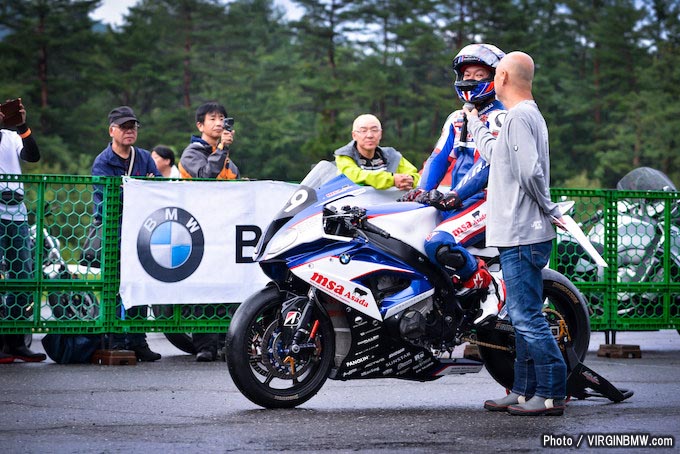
[{"xmin": 566, "ymin": 343, "xmax": 633, "ymax": 402}]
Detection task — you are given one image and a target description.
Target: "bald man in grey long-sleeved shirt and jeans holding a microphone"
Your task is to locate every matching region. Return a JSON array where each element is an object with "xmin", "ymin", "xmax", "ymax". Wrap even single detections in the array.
[{"xmin": 466, "ymin": 52, "xmax": 567, "ymax": 416}]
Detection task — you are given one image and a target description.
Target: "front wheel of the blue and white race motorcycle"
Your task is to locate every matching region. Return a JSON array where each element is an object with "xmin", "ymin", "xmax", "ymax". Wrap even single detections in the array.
[{"xmin": 227, "ymin": 287, "xmax": 334, "ymax": 408}]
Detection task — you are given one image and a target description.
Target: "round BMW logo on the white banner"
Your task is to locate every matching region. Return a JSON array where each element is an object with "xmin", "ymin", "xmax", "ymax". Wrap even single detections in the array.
[{"xmin": 137, "ymin": 207, "xmax": 204, "ymax": 282}]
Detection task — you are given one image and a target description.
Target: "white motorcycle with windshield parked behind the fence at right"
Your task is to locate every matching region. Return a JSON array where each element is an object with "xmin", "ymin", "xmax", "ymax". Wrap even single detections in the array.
[{"xmin": 557, "ymin": 167, "xmax": 680, "ymax": 317}]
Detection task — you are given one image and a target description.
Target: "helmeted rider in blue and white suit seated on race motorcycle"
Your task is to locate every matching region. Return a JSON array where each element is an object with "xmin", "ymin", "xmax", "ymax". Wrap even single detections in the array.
[{"xmin": 401, "ymin": 44, "xmax": 506, "ymax": 323}]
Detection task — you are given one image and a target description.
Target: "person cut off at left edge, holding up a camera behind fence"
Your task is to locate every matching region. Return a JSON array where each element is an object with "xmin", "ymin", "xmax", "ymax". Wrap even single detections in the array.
[{"xmin": 0, "ymin": 98, "xmax": 46, "ymax": 364}]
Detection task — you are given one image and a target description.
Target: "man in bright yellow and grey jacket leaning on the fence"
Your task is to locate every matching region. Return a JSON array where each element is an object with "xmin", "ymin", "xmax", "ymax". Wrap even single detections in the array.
[{"xmin": 334, "ymin": 114, "xmax": 420, "ymax": 191}]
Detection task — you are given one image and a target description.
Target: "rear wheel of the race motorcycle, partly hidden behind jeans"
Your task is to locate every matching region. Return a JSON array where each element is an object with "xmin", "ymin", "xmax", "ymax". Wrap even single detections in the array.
[{"xmin": 477, "ymin": 269, "xmax": 590, "ymax": 389}]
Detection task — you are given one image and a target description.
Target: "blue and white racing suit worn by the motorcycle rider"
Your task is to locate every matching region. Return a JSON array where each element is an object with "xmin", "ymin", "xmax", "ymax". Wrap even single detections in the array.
[{"xmin": 420, "ymin": 100, "xmax": 506, "ymax": 282}]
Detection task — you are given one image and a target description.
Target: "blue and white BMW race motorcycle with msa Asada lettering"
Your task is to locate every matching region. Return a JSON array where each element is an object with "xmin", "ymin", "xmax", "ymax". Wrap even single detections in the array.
[{"xmin": 226, "ymin": 162, "xmax": 590, "ymax": 408}]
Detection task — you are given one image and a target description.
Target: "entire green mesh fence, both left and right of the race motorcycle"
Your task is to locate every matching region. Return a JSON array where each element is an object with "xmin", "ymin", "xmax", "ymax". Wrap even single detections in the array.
[{"xmin": 0, "ymin": 175, "xmax": 680, "ymax": 333}]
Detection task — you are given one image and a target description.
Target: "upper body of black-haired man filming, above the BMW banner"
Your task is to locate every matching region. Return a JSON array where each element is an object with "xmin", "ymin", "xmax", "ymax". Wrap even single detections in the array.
[{"xmin": 179, "ymin": 102, "xmax": 241, "ymax": 180}]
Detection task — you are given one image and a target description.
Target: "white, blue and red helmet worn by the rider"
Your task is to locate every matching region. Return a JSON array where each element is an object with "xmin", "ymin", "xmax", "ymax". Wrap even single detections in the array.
[{"xmin": 453, "ymin": 44, "xmax": 505, "ymax": 104}]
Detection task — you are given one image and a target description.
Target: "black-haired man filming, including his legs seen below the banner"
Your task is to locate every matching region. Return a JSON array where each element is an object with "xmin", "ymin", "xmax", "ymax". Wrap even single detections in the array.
[{"xmin": 178, "ymin": 101, "xmax": 241, "ymax": 362}]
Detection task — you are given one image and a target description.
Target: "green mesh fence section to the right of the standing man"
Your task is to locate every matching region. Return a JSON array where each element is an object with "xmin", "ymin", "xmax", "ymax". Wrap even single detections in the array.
[{"xmin": 551, "ymin": 189, "xmax": 680, "ymax": 331}]
